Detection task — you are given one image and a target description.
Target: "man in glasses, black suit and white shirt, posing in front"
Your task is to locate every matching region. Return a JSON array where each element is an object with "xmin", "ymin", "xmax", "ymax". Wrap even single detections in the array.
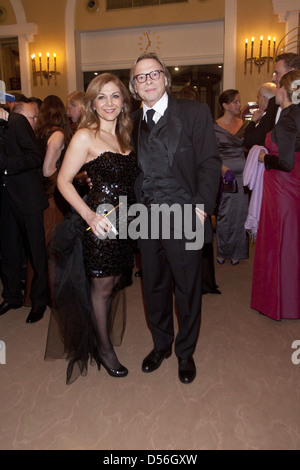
[{"xmin": 129, "ymin": 53, "xmax": 221, "ymax": 383}]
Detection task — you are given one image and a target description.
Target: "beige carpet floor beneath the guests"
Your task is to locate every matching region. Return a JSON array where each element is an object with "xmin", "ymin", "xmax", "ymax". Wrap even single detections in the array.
[{"xmin": 0, "ymin": 241, "xmax": 300, "ymax": 451}]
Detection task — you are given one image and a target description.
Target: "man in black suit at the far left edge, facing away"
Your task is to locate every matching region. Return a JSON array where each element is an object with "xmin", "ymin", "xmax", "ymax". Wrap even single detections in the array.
[{"xmin": 0, "ymin": 108, "xmax": 48, "ymax": 323}]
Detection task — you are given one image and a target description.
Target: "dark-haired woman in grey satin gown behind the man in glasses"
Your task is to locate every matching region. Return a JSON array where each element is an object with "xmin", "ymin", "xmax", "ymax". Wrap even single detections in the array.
[{"xmin": 214, "ymin": 89, "xmax": 249, "ymax": 266}]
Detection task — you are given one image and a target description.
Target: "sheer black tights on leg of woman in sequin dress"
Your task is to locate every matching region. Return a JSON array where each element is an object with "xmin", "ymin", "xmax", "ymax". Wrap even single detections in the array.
[{"xmin": 91, "ymin": 276, "xmax": 121, "ymax": 369}]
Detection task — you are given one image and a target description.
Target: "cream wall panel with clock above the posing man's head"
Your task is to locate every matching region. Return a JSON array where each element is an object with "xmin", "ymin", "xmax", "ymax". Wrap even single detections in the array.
[{"xmin": 80, "ymin": 21, "xmax": 224, "ymax": 71}]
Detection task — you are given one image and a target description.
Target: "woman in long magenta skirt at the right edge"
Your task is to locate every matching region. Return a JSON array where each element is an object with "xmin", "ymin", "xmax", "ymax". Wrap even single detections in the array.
[{"xmin": 251, "ymin": 70, "xmax": 300, "ymax": 320}]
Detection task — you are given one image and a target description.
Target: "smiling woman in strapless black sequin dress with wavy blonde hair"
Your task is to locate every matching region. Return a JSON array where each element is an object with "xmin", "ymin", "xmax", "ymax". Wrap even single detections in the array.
[{"xmin": 46, "ymin": 73, "xmax": 139, "ymax": 383}]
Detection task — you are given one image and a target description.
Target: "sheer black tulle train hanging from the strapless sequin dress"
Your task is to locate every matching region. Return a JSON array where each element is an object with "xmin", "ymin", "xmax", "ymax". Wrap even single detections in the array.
[{"xmin": 45, "ymin": 213, "xmax": 132, "ymax": 384}]
